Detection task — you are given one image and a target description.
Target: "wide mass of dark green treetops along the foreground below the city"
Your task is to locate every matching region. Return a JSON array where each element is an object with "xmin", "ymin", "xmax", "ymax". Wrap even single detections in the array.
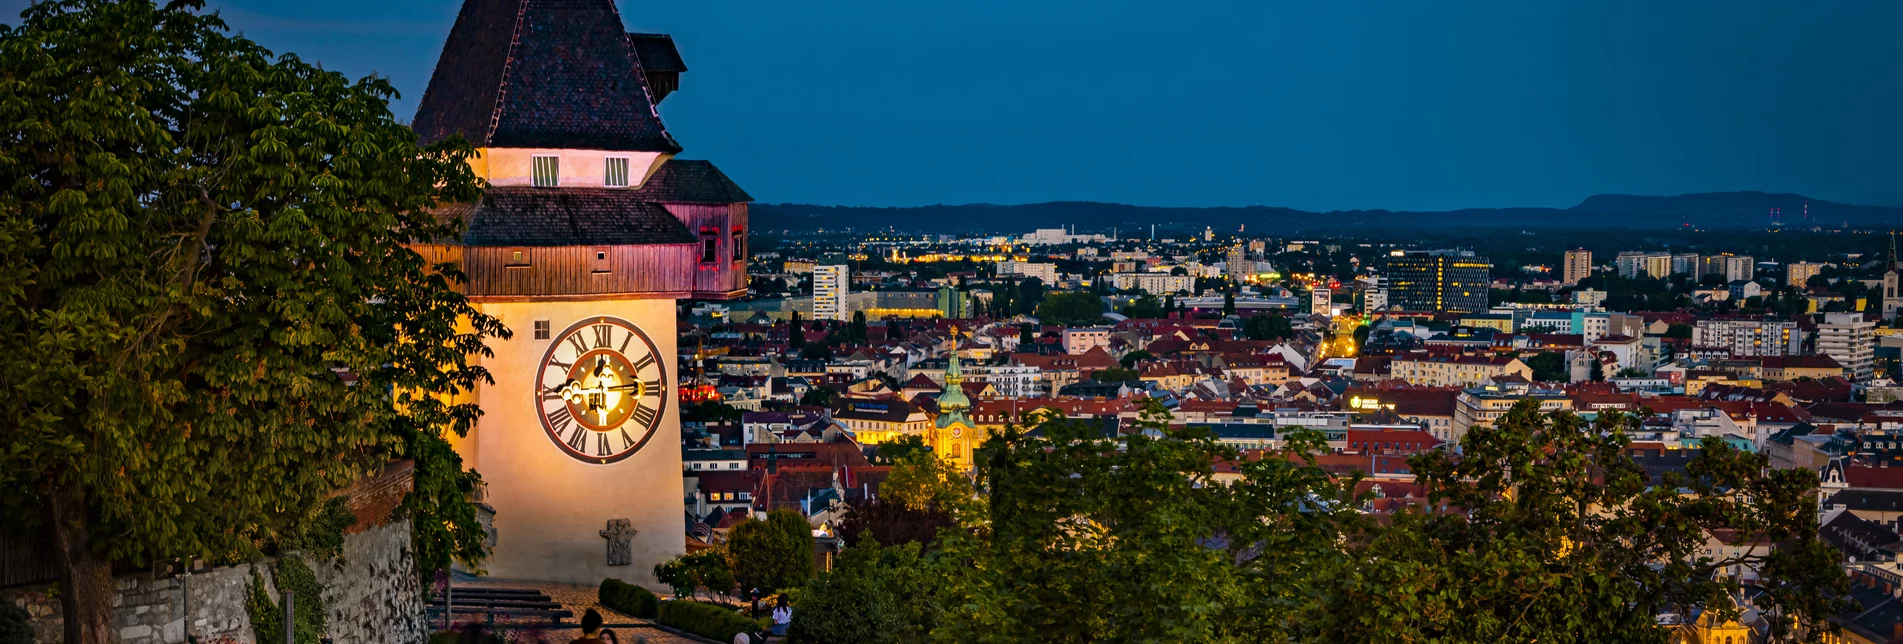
[{"xmin": 810, "ymin": 404, "xmax": 1848, "ymax": 642}]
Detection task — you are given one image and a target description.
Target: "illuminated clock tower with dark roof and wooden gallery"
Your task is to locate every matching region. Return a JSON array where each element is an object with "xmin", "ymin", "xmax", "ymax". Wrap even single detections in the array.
[{"xmin": 415, "ymin": 0, "xmax": 752, "ymax": 585}]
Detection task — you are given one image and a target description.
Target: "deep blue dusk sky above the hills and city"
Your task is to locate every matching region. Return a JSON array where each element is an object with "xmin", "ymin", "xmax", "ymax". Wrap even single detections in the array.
[{"xmin": 0, "ymin": 0, "xmax": 1903, "ymax": 210}]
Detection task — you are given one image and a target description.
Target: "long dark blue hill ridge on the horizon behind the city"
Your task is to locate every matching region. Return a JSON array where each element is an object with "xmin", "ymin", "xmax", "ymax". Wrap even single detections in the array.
[{"xmin": 752, "ymin": 192, "xmax": 1903, "ymax": 234}]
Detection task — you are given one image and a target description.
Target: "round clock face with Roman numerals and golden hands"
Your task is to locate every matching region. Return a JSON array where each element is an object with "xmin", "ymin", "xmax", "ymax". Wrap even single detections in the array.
[{"xmin": 535, "ymin": 318, "xmax": 668, "ymax": 465}]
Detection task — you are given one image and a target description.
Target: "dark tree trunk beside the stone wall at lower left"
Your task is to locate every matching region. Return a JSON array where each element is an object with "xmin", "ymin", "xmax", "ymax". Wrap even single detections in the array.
[{"xmin": 46, "ymin": 484, "xmax": 112, "ymax": 644}]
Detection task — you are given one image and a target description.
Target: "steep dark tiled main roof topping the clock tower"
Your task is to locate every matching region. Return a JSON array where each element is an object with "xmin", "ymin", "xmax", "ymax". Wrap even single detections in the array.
[{"xmin": 413, "ymin": 0, "xmax": 681, "ymax": 154}]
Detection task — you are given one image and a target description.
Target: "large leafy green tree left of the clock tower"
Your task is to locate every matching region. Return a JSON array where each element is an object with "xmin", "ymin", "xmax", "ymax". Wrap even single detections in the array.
[{"xmin": 0, "ymin": 0, "xmax": 508, "ymax": 644}]
